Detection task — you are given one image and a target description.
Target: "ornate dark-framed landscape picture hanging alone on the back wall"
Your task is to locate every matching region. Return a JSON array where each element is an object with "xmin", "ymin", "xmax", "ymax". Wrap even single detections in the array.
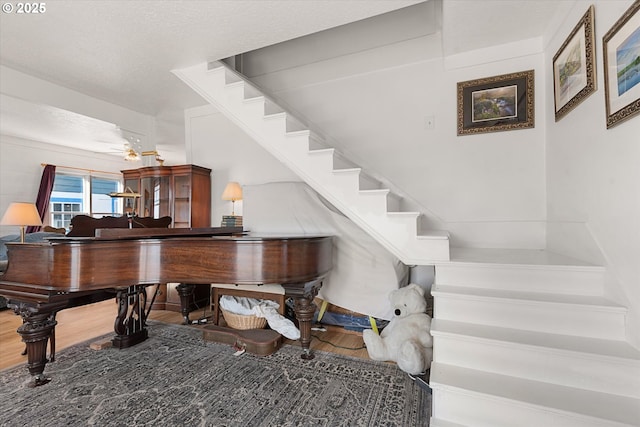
[{"xmin": 458, "ymin": 70, "xmax": 534, "ymax": 135}]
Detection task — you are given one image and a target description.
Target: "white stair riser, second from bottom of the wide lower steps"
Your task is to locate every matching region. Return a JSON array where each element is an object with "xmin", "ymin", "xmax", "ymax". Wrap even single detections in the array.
[{"xmin": 432, "ymin": 331, "xmax": 640, "ymax": 398}]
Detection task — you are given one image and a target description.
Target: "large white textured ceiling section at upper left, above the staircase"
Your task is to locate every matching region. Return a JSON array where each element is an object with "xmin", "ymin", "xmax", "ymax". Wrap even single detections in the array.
[{"xmin": 0, "ymin": 0, "xmax": 428, "ymax": 115}]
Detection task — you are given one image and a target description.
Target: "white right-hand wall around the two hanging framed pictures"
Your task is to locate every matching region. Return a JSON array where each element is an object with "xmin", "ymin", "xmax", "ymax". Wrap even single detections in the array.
[{"xmin": 544, "ymin": 0, "xmax": 640, "ymax": 346}]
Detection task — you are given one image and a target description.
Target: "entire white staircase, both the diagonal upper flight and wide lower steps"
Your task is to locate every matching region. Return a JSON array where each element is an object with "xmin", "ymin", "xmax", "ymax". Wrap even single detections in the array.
[{"xmin": 174, "ymin": 62, "xmax": 640, "ymax": 427}]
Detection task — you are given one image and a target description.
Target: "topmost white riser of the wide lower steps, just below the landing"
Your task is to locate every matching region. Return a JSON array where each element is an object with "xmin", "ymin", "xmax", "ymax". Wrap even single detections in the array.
[{"xmin": 435, "ymin": 264, "xmax": 605, "ymax": 295}]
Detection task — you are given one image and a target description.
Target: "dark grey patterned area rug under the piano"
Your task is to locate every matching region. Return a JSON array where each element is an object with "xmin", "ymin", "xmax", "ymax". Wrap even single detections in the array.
[{"xmin": 0, "ymin": 322, "xmax": 431, "ymax": 427}]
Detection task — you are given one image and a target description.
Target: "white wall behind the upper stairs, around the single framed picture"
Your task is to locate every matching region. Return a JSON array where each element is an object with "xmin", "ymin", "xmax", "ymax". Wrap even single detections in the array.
[{"xmin": 238, "ymin": 26, "xmax": 546, "ymax": 249}]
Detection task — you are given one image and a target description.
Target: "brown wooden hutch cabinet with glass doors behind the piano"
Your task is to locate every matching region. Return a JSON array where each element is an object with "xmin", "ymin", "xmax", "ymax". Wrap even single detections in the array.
[{"xmin": 122, "ymin": 165, "xmax": 211, "ymax": 312}]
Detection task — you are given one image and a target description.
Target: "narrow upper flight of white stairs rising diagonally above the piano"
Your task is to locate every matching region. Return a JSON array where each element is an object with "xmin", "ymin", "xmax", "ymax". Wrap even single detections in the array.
[{"xmin": 174, "ymin": 62, "xmax": 449, "ymax": 265}]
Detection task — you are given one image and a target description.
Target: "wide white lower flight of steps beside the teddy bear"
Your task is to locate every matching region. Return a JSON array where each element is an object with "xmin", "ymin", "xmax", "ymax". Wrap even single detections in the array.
[{"xmin": 430, "ymin": 249, "xmax": 640, "ymax": 427}]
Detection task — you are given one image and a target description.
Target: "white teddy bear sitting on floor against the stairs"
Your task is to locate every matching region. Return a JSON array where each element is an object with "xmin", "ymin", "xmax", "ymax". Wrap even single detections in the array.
[{"xmin": 362, "ymin": 283, "xmax": 433, "ymax": 375}]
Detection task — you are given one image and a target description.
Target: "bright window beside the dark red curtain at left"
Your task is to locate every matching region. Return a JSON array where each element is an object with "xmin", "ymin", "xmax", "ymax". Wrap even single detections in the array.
[{"xmin": 49, "ymin": 173, "xmax": 122, "ymax": 230}]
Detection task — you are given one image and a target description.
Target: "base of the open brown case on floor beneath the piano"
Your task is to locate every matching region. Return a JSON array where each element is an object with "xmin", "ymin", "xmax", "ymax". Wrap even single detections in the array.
[{"xmin": 202, "ymin": 325, "xmax": 282, "ymax": 356}]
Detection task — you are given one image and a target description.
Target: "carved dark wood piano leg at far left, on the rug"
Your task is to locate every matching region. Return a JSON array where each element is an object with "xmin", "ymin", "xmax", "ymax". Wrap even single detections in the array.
[{"xmin": 9, "ymin": 302, "xmax": 63, "ymax": 387}]
